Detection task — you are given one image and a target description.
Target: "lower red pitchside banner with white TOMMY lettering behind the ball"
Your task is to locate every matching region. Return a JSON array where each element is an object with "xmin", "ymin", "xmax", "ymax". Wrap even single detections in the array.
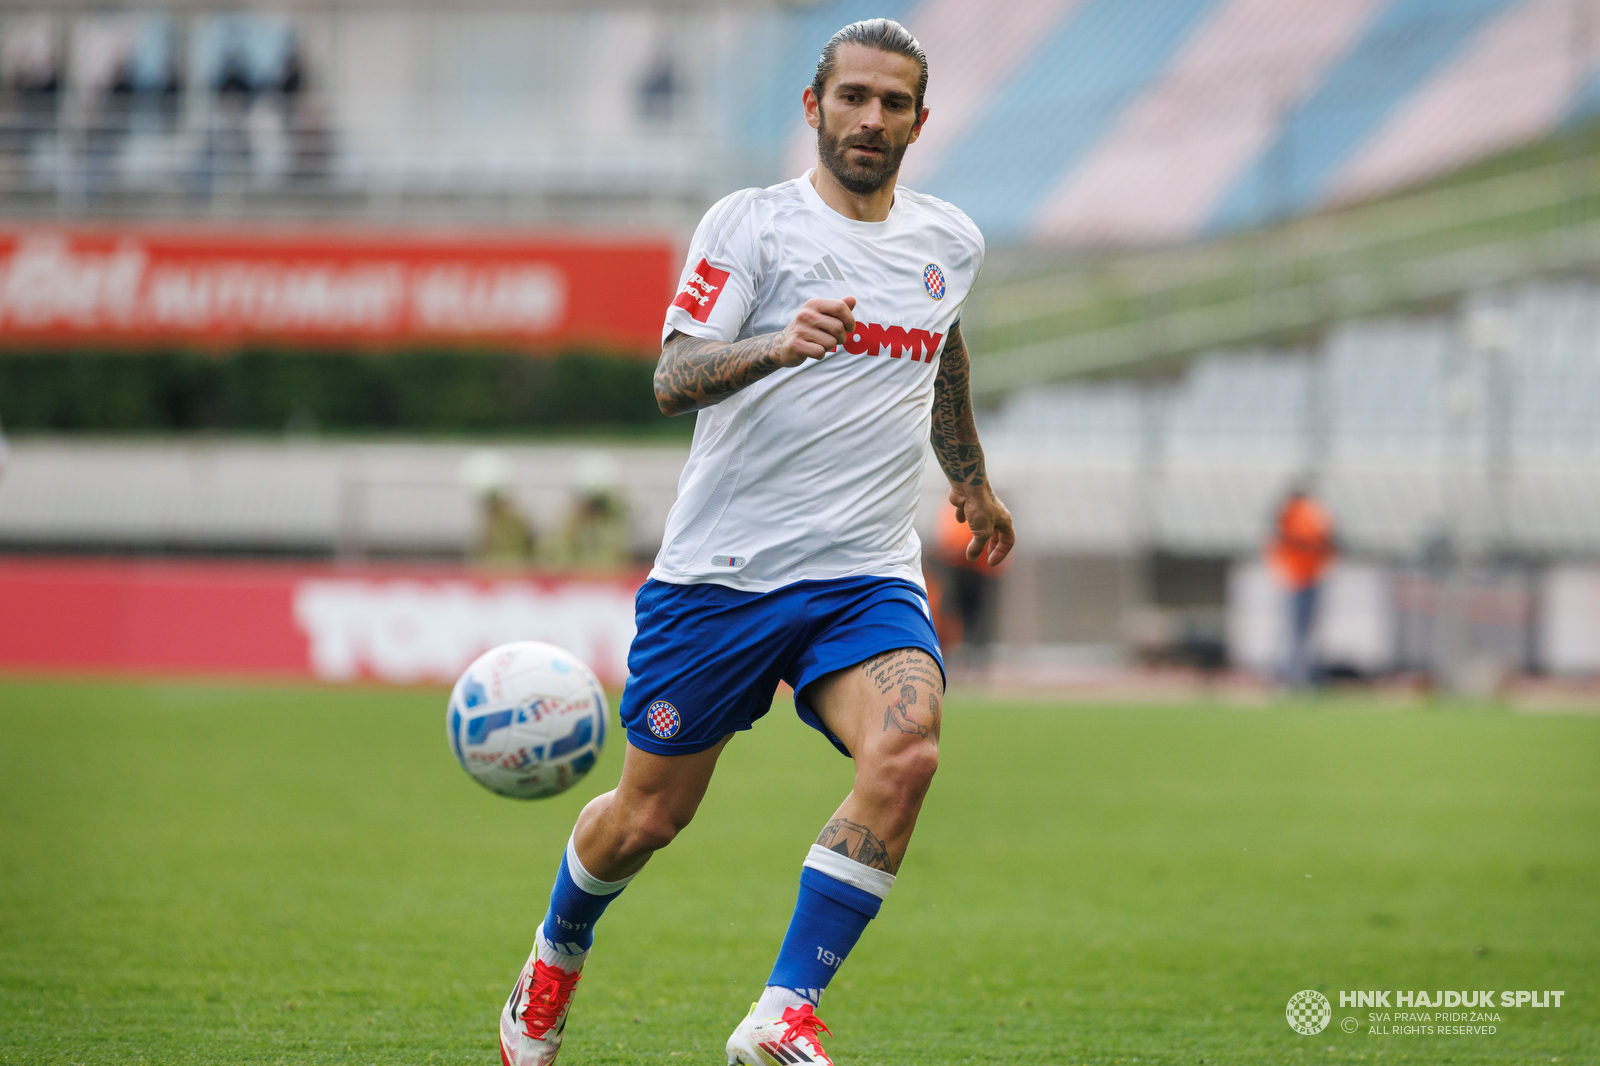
[{"xmin": 0, "ymin": 559, "xmax": 643, "ymax": 688}]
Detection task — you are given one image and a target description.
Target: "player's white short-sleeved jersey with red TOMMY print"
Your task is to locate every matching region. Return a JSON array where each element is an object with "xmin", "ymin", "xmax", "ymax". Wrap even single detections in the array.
[{"xmin": 650, "ymin": 173, "xmax": 984, "ymax": 592}]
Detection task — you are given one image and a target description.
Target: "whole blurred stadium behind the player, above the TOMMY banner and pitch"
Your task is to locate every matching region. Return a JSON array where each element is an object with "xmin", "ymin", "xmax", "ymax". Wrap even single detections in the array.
[{"xmin": 0, "ymin": 0, "xmax": 1600, "ymax": 690}]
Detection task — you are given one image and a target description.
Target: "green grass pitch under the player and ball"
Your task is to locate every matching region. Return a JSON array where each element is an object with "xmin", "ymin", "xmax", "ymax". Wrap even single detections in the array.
[{"xmin": 0, "ymin": 680, "xmax": 1600, "ymax": 1066}]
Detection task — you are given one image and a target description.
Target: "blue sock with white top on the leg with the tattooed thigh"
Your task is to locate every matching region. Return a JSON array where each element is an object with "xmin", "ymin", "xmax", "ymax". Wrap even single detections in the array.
[{"xmin": 766, "ymin": 845, "xmax": 894, "ymax": 1005}]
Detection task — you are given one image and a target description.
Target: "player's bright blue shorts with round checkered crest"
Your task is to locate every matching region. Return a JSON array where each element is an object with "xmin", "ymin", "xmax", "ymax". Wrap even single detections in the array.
[{"xmin": 622, "ymin": 578, "xmax": 944, "ymax": 755}]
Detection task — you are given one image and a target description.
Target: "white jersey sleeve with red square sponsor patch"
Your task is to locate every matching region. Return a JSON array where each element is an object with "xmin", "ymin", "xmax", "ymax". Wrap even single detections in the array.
[{"xmin": 661, "ymin": 189, "xmax": 762, "ymax": 343}]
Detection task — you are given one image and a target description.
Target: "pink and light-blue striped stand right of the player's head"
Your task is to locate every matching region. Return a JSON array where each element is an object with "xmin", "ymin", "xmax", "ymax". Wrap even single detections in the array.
[{"xmin": 768, "ymin": 0, "xmax": 1600, "ymax": 246}]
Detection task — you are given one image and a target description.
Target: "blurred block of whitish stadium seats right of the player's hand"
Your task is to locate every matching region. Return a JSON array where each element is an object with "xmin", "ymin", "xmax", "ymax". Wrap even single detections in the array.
[{"xmin": 982, "ymin": 283, "xmax": 1600, "ymax": 559}]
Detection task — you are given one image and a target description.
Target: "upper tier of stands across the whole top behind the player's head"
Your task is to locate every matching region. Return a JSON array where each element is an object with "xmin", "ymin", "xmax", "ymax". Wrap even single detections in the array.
[{"xmin": 9, "ymin": 0, "xmax": 1600, "ymax": 238}]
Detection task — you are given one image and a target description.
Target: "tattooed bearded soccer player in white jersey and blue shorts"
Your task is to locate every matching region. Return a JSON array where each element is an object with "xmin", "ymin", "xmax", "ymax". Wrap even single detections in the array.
[{"xmin": 501, "ymin": 19, "xmax": 1014, "ymax": 1066}]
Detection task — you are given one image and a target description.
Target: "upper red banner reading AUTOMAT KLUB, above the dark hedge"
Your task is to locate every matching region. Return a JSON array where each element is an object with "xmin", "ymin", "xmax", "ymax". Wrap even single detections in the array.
[{"xmin": 0, "ymin": 227, "xmax": 677, "ymax": 352}]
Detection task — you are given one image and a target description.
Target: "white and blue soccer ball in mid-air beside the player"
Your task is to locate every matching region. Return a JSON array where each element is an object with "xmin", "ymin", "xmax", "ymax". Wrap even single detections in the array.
[{"xmin": 445, "ymin": 640, "xmax": 610, "ymax": 799}]
